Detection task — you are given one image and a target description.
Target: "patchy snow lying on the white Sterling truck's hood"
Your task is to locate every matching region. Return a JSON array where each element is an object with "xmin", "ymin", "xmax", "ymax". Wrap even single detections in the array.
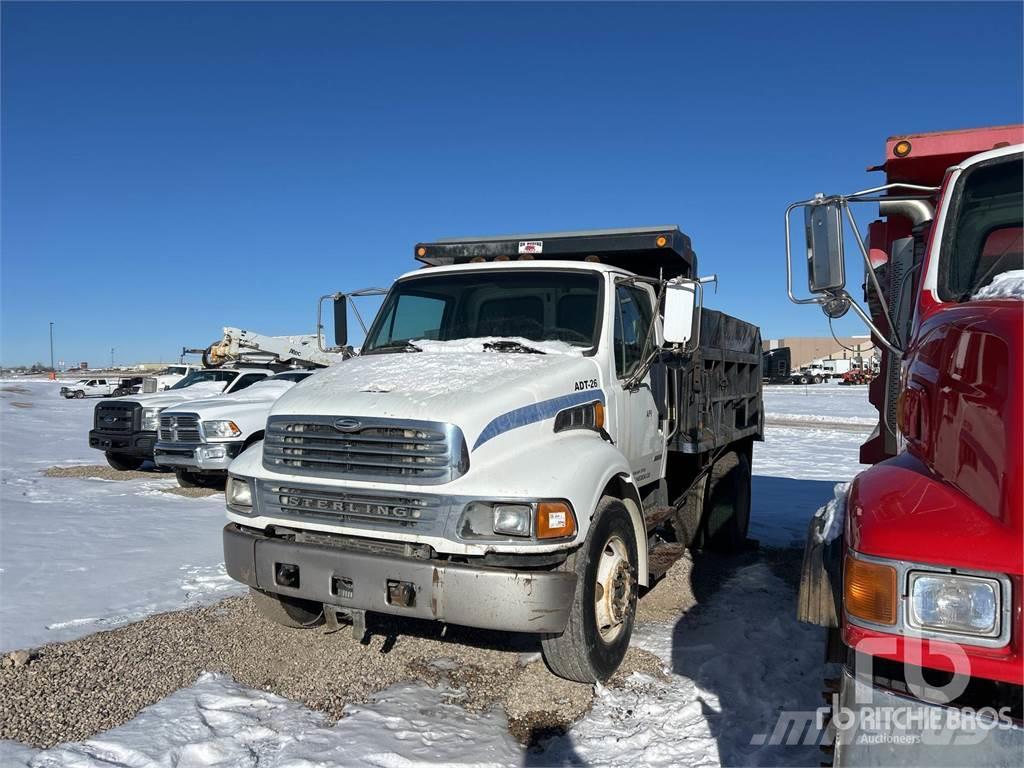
[{"xmin": 302, "ymin": 337, "xmax": 583, "ymax": 397}]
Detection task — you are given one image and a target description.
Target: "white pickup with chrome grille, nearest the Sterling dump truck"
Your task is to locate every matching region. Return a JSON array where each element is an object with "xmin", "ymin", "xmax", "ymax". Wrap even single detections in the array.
[{"xmin": 154, "ymin": 371, "xmax": 313, "ymax": 487}]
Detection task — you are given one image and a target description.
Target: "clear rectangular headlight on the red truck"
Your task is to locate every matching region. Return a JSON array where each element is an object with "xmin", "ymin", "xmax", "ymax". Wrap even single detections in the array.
[{"xmin": 907, "ymin": 571, "xmax": 999, "ymax": 637}]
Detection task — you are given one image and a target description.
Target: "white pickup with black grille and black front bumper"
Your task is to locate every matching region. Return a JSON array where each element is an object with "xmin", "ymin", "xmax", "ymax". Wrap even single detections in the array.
[{"xmin": 89, "ymin": 368, "xmax": 274, "ymax": 470}]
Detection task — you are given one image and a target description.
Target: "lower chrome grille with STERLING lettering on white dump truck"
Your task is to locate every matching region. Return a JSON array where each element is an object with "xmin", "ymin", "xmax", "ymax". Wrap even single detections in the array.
[{"xmin": 257, "ymin": 480, "xmax": 443, "ymax": 531}]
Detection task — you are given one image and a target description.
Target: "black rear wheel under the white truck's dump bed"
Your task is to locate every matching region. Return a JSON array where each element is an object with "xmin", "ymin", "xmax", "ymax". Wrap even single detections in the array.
[{"xmin": 705, "ymin": 451, "xmax": 751, "ymax": 552}]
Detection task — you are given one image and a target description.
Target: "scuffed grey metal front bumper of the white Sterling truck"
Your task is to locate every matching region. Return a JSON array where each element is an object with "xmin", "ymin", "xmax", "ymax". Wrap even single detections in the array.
[{"xmin": 223, "ymin": 523, "xmax": 575, "ymax": 634}]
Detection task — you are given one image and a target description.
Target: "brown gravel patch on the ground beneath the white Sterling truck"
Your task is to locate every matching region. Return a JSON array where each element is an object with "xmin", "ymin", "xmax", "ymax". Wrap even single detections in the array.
[{"xmin": 0, "ymin": 552, "xmax": 695, "ymax": 748}]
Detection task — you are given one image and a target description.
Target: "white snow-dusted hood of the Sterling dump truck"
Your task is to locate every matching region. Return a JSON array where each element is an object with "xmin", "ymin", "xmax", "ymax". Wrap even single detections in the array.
[{"xmin": 270, "ymin": 339, "xmax": 600, "ymax": 445}]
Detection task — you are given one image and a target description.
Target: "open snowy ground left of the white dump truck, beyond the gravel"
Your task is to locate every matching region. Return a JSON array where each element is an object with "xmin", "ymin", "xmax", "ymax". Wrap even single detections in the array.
[{"xmin": 0, "ymin": 380, "xmax": 239, "ymax": 651}]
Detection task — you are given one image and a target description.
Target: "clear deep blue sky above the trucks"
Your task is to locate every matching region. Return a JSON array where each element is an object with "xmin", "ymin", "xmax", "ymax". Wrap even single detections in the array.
[{"xmin": 0, "ymin": 3, "xmax": 1024, "ymax": 365}]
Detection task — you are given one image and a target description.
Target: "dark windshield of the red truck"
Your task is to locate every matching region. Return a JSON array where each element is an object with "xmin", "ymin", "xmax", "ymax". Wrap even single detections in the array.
[{"xmin": 939, "ymin": 155, "xmax": 1024, "ymax": 301}]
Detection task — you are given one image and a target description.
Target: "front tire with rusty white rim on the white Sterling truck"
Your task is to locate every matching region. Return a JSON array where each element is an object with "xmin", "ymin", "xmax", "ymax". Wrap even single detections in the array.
[{"xmin": 541, "ymin": 497, "xmax": 638, "ymax": 683}]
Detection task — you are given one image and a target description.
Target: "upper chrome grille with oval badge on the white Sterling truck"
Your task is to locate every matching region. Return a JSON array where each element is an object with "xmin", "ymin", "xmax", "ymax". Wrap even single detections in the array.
[{"xmin": 263, "ymin": 416, "xmax": 469, "ymax": 484}]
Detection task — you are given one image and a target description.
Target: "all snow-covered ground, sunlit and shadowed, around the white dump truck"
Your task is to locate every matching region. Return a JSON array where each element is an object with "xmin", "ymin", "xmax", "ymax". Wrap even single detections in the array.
[{"xmin": 0, "ymin": 376, "xmax": 872, "ymax": 767}]
